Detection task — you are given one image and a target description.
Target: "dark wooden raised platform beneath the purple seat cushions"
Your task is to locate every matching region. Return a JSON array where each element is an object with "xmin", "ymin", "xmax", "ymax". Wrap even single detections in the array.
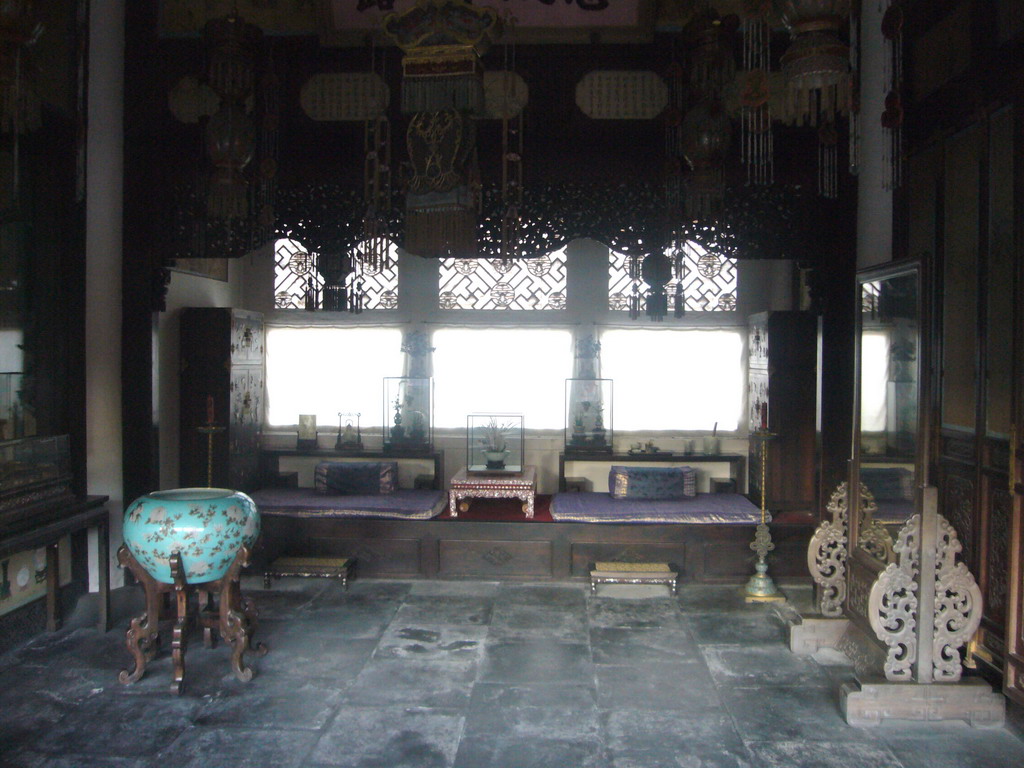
[{"xmin": 255, "ymin": 496, "xmax": 814, "ymax": 584}]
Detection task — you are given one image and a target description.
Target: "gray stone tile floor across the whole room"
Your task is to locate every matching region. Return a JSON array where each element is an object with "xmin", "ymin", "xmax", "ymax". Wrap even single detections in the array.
[{"xmin": 0, "ymin": 579, "xmax": 1024, "ymax": 768}]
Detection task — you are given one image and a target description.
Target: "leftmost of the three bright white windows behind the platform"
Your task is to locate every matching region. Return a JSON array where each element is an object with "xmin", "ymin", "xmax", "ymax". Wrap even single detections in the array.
[{"xmin": 266, "ymin": 328, "xmax": 403, "ymax": 428}]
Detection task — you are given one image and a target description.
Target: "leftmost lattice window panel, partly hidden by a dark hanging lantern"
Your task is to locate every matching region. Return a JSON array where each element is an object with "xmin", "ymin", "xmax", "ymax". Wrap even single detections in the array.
[{"xmin": 273, "ymin": 240, "xmax": 398, "ymax": 309}]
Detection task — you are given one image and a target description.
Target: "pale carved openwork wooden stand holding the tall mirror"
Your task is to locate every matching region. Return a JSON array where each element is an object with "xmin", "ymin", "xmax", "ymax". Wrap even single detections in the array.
[{"xmin": 790, "ymin": 483, "xmax": 1006, "ymax": 726}]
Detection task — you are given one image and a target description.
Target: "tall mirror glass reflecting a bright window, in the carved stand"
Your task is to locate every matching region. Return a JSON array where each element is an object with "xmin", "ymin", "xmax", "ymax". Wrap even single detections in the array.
[{"xmin": 851, "ymin": 265, "xmax": 922, "ymax": 561}]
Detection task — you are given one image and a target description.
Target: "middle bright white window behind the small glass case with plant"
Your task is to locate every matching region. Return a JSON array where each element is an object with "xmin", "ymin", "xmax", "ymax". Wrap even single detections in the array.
[{"xmin": 433, "ymin": 328, "xmax": 577, "ymax": 429}]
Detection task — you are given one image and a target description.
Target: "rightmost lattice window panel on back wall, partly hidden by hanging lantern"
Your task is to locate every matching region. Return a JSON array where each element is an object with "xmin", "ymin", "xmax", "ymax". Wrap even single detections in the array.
[{"xmin": 608, "ymin": 241, "xmax": 736, "ymax": 312}]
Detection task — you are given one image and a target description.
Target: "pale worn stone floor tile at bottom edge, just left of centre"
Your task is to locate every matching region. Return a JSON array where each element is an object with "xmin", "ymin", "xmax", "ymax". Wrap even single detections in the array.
[{"xmin": 309, "ymin": 707, "xmax": 463, "ymax": 768}]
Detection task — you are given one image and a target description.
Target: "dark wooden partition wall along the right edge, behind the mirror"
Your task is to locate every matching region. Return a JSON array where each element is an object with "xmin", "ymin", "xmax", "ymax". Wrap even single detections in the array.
[{"xmin": 897, "ymin": 2, "xmax": 1024, "ymax": 701}]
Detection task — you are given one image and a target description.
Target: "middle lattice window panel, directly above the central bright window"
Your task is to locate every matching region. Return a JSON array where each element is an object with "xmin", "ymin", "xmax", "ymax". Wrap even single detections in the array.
[{"xmin": 437, "ymin": 244, "xmax": 565, "ymax": 309}]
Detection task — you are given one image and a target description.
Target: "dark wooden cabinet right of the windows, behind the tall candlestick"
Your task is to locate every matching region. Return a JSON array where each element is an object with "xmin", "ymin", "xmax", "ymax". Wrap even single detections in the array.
[{"xmin": 746, "ymin": 311, "xmax": 817, "ymax": 513}]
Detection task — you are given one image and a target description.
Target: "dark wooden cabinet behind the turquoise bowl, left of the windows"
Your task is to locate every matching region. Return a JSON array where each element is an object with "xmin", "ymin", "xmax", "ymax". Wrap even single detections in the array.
[{"xmin": 178, "ymin": 307, "xmax": 264, "ymax": 490}]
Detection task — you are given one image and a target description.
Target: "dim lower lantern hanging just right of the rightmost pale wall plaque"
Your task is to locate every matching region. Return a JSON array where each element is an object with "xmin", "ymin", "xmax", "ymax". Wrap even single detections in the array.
[{"xmin": 681, "ymin": 100, "xmax": 732, "ymax": 221}]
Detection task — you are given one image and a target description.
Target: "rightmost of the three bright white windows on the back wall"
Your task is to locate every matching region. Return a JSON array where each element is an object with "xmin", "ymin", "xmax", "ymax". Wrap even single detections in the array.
[{"xmin": 601, "ymin": 329, "xmax": 745, "ymax": 432}]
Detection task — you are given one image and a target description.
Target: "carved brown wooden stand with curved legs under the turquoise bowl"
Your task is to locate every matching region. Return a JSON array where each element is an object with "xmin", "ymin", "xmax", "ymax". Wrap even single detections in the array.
[{"xmin": 118, "ymin": 545, "xmax": 267, "ymax": 693}]
